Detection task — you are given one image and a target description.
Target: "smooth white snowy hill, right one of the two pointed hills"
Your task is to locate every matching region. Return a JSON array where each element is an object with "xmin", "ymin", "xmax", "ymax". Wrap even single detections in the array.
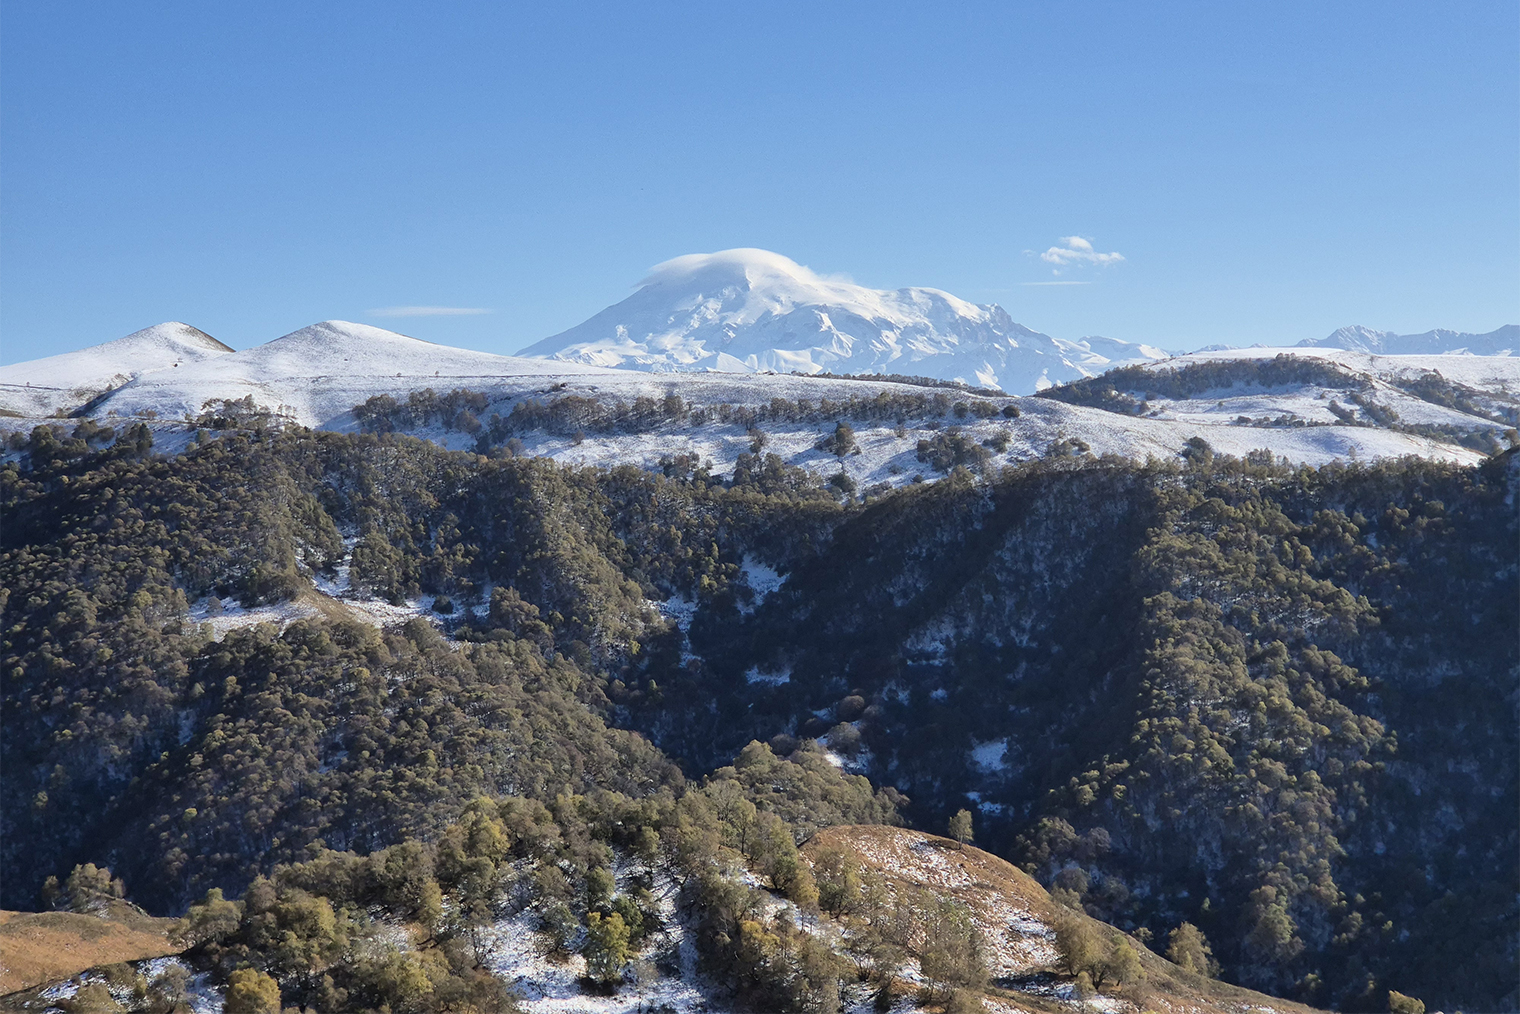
[{"xmin": 97, "ymin": 321, "xmax": 608, "ymax": 426}]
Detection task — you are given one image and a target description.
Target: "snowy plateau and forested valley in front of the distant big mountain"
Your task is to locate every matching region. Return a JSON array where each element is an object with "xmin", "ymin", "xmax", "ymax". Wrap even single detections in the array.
[{"xmin": 0, "ymin": 294, "xmax": 1520, "ymax": 1014}]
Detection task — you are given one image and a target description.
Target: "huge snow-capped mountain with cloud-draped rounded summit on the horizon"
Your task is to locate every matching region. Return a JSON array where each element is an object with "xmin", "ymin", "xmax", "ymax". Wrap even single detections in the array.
[{"xmin": 518, "ymin": 249, "xmax": 1166, "ymax": 394}]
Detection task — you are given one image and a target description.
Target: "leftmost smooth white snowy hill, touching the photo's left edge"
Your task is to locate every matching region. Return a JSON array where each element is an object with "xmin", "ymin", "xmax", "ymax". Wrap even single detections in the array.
[{"xmin": 0, "ymin": 321, "xmax": 233, "ymax": 417}]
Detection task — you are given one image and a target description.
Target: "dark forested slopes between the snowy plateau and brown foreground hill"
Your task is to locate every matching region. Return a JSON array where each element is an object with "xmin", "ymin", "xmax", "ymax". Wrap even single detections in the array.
[{"xmin": 0, "ymin": 426, "xmax": 1520, "ymax": 1009}]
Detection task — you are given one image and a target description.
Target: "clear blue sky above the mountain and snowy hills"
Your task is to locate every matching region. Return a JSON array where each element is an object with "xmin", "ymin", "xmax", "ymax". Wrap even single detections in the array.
[{"xmin": 0, "ymin": 0, "xmax": 1520, "ymax": 362}]
